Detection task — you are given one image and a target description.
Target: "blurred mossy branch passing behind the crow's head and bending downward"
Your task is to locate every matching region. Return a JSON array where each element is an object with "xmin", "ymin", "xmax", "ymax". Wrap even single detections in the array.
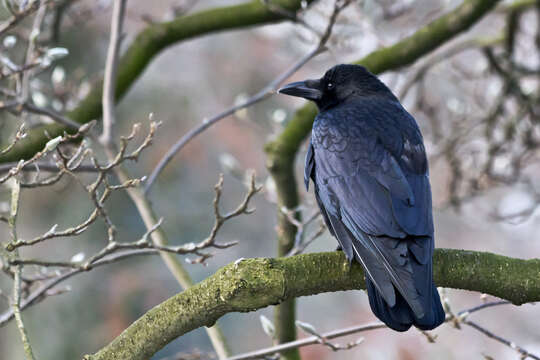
[{"xmin": 265, "ymin": 0, "xmax": 504, "ymax": 359}]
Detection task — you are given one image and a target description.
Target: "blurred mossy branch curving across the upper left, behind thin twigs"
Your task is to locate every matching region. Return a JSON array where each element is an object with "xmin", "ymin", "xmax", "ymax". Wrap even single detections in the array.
[{"xmin": 0, "ymin": 0, "xmax": 313, "ymax": 163}]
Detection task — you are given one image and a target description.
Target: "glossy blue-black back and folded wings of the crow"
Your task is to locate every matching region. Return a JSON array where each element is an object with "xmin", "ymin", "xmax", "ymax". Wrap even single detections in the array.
[{"xmin": 304, "ymin": 100, "xmax": 433, "ymax": 318}]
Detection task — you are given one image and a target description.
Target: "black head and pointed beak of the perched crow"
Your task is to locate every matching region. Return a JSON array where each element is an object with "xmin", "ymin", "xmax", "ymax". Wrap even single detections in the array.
[{"xmin": 278, "ymin": 64, "xmax": 395, "ymax": 110}]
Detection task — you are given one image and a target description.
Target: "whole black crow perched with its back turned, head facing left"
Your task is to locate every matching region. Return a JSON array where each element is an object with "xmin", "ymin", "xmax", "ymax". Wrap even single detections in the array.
[{"xmin": 279, "ymin": 65, "xmax": 445, "ymax": 331}]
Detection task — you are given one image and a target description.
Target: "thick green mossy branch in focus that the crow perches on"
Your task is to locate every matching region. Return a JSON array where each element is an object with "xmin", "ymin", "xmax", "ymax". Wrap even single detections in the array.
[{"xmin": 85, "ymin": 249, "xmax": 540, "ymax": 360}]
